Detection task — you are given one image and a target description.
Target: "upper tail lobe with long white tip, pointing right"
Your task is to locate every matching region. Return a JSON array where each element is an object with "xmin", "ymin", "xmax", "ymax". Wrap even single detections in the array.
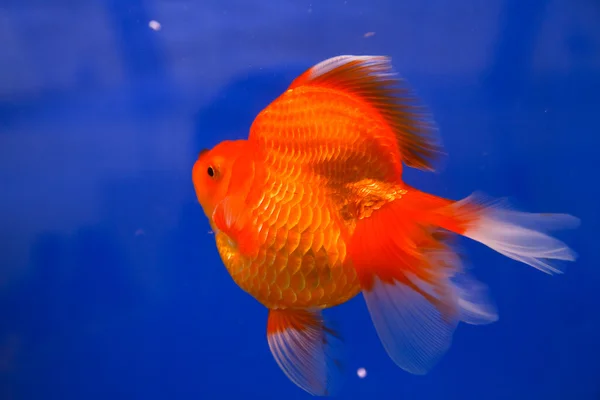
[{"xmin": 438, "ymin": 194, "xmax": 580, "ymax": 274}]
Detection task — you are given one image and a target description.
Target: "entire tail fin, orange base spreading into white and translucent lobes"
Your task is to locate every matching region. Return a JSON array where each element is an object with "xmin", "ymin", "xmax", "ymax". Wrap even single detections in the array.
[{"xmin": 348, "ymin": 190, "xmax": 578, "ymax": 374}]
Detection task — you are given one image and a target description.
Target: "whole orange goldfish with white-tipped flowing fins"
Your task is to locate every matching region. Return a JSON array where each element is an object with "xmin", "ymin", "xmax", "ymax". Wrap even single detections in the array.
[{"xmin": 192, "ymin": 56, "xmax": 578, "ymax": 395}]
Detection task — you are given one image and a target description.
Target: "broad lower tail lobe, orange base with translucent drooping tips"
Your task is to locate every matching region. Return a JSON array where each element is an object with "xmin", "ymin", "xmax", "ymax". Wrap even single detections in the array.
[{"xmin": 348, "ymin": 192, "xmax": 497, "ymax": 374}]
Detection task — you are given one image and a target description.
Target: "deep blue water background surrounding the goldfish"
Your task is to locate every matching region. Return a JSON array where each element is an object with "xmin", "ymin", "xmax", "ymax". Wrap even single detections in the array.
[{"xmin": 0, "ymin": 0, "xmax": 600, "ymax": 400}]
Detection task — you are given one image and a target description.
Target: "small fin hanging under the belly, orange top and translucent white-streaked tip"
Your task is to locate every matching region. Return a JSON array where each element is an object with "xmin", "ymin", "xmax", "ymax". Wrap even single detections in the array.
[{"xmin": 267, "ymin": 309, "xmax": 342, "ymax": 396}]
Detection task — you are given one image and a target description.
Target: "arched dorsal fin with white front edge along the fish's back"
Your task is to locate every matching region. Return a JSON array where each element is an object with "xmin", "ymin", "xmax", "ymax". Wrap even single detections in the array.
[{"xmin": 289, "ymin": 55, "xmax": 442, "ymax": 170}]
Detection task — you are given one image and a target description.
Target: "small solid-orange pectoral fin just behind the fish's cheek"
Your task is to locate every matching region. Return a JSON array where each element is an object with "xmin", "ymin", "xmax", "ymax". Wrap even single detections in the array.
[{"xmin": 212, "ymin": 196, "xmax": 259, "ymax": 256}]
